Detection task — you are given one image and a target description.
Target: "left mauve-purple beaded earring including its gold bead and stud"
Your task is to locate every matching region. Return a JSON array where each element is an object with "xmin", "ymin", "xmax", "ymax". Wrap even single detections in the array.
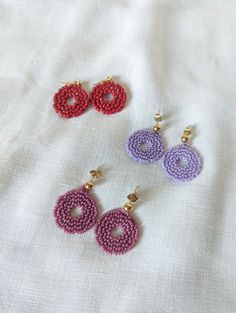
[{"xmin": 53, "ymin": 168, "xmax": 102, "ymax": 234}]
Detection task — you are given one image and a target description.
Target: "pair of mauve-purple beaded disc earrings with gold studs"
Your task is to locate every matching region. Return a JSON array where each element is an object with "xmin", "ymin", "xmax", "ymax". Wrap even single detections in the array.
[{"xmin": 53, "ymin": 168, "xmax": 139, "ymax": 254}]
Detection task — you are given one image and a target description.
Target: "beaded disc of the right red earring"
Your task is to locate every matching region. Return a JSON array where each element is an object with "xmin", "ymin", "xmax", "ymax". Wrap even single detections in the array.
[{"xmin": 90, "ymin": 81, "xmax": 127, "ymax": 114}]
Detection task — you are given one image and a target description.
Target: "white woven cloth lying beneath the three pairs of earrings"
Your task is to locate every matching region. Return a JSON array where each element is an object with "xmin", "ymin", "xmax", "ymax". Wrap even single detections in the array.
[{"xmin": 0, "ymin": 0, "xmax": 236, "ymax": 313}]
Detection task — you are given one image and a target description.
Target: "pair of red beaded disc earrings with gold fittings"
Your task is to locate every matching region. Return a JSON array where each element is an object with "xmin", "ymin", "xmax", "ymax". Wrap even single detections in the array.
[{"xmin": 53, "ymin": 76, "xmax": 127, "ymax": 118}]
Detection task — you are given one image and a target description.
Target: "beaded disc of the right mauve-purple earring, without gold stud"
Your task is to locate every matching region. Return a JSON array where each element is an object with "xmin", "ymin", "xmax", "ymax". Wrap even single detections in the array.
[{"xmin": 95, "ymin": 208, "xmax": 138, "ymax": 254}]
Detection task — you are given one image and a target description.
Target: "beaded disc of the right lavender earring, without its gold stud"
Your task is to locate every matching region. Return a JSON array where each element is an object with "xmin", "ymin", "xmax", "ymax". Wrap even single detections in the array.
[{"xmin": 162, "ymin": 144, "xmax": 201, "ymax": 182}]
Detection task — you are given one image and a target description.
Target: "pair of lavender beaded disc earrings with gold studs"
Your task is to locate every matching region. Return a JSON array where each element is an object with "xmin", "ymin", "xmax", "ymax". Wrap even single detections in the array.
[{"xmin": 126, "ymin": 113, "xmax": 202, "ymax": 182}]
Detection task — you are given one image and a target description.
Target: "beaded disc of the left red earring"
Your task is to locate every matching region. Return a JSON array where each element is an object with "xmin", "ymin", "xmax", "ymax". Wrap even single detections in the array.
[{"xmin": 53, "ymin": 84, "xmax": 89, "ymax": 118}]
